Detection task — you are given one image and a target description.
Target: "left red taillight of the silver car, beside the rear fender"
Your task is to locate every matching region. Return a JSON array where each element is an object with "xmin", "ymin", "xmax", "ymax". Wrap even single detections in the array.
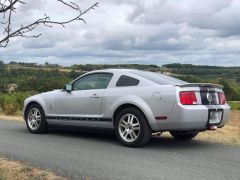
[{"xmin": 179, "ymin": 91, "xmax": 197, "ymax": 105}]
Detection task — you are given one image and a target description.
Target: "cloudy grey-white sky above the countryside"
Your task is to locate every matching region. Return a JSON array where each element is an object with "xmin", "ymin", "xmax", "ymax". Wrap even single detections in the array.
[{"xmin": 0, "ymin": 0, "xmax": 240, "ymax": 66}]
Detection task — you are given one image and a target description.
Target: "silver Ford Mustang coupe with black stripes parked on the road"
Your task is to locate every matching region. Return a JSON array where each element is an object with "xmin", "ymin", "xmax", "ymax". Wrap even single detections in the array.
[{"xmin": 23, "ymin": 69, "xmax": 230, "ymax": 147}]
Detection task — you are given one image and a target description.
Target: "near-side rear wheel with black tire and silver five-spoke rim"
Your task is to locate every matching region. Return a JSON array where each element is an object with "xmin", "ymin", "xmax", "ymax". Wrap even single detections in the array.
[{"xmin": 114, "ymin": 107, "xmax": 152, "ymax": 147}]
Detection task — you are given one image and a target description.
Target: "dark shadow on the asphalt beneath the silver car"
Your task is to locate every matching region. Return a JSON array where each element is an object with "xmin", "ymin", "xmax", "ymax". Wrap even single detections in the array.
[{"xmin": 44, "ymin": 127, "xmax": 212, "ymax": 149}]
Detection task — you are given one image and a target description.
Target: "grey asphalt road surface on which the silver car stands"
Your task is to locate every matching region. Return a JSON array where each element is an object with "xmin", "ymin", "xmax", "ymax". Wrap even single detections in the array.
[{"xmin": 0, "ymin": 121, "xmax": 240, "ymax": 180}]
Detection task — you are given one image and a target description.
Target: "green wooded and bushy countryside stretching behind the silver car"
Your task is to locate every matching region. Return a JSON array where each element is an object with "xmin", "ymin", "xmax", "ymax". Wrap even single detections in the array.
[{"xmin": 0, "ymin": 61, "xmax": 240, "ymax": 115}]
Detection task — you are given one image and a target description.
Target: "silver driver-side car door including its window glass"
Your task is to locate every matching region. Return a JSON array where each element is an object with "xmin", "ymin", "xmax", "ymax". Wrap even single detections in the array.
[{"xmin": 55, "ymin": 73, "xmax": 113, "ymax": 117}]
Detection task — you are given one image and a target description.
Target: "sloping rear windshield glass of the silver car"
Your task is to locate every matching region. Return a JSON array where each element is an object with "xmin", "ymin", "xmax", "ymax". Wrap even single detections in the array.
[{"xmin": 131, "ymin": 71, "xmax": 187, "ymax": 85}]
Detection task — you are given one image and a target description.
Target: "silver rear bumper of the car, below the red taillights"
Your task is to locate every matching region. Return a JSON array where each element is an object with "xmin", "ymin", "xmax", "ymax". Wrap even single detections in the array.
[{"xmin": 152, "ymin": 104, "xmax": 230, "ymax": 131}]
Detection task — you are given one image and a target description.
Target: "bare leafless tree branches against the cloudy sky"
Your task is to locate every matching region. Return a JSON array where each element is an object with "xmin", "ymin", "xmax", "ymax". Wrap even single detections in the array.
[{"xmin": 0, "ymin": 0, "xmax": 98, "ymax": 47}]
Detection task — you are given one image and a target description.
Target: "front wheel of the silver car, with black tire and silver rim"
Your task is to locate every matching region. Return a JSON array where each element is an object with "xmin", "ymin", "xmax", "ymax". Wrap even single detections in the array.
[{"xmin": 25, "ymin": 104, "xmax": 48, "ymax": 134}]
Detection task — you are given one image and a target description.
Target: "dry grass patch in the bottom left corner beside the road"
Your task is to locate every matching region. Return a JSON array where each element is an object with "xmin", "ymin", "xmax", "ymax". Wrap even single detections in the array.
[{"xmin": 0, "ymin": 158, "xmax": 65, "ymax": 180}]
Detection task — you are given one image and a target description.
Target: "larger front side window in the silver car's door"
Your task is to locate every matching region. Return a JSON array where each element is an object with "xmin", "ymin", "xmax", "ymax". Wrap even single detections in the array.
[{"xmin": 73, "ymin": 73, "xmax": 113, "ymax": 91}]
